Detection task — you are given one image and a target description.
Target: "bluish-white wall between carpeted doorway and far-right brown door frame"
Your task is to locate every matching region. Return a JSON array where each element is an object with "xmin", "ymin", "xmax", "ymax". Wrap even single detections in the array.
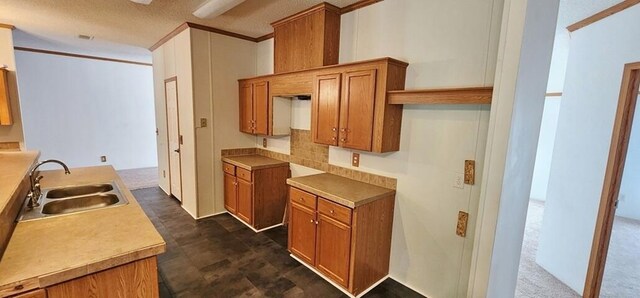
[{"xmin": 537, "ymin": 5, "xmax": 640, "ymax": 293}]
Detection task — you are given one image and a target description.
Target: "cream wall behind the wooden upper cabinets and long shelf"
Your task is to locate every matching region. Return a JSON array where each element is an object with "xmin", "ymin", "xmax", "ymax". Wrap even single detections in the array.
[{"xmin": 257, "ymin": 0, "xmax": 502, "ymax": 297}]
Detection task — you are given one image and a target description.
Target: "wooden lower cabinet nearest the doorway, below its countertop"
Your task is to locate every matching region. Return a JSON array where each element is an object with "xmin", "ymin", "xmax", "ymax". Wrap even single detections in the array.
[{"xmin": 289, "ymin": 187, "xmax": 395, "ymax": 296}]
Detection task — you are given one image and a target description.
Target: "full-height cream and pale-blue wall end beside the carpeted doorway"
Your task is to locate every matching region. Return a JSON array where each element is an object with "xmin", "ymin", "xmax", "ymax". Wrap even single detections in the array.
[{"xmin": 469, "ymin": 0, "xmax": 559, "ymax": 297}]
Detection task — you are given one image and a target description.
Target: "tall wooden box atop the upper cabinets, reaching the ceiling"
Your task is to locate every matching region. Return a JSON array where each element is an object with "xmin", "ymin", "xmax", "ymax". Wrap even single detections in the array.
[{"xmin": 271, "ymin": 3, "xmax": 340, "ymax": 73}]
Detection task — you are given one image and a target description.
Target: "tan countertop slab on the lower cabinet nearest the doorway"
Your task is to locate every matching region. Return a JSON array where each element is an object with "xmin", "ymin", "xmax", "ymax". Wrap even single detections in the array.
[{"xmin": 287, "ymin": 173, "xmax": 396, "ymax": 208}]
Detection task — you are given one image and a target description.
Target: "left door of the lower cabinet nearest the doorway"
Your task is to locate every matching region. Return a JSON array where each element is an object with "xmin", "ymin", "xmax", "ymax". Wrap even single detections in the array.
[{"xmin": 289, "ymin": 202, "xmax": 316, "ymax": 265}]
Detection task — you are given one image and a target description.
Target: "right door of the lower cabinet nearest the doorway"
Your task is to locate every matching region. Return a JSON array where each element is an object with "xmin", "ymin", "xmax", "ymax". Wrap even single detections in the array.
[{"xmin": 316, "ymin": 214, "xmax": 351, "ymax": 287}]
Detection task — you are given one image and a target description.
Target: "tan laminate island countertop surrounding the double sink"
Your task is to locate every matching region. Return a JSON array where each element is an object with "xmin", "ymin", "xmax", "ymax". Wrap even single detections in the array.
[{"xmin": 0, "ymin": 166, "xmax": 165, "ymax": 297}]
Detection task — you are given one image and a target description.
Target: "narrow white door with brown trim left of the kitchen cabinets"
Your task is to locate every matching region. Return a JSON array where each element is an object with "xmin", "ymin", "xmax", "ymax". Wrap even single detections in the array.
[{"xmin": 164, "ymin": 78, "xmax": 182, "ymax": 201}]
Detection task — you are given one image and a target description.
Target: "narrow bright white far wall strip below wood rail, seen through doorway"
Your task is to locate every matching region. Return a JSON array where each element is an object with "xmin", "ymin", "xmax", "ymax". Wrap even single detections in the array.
[{"xmin": 530, "ymin": 98, "xmax": 561, "ymax": 201}]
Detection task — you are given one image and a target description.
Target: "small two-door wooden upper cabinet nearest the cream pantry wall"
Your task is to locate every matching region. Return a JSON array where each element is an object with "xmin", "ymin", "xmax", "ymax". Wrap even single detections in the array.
[{"xmin": 240, "ymin": 81, "xmax": 269, "ymax": 135}]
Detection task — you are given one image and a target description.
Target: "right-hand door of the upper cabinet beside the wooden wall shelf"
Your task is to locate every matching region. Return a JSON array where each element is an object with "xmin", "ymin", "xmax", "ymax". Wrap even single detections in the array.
[{"xmin": 340, "ymin": 69, "xmax": 376, "ymax": 151}]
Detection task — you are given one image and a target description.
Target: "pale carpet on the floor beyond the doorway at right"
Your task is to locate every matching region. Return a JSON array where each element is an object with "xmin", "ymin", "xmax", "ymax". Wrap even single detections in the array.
[{"xmin": 515, "ymin": 200, "xmax": 640, "ymax": 298}]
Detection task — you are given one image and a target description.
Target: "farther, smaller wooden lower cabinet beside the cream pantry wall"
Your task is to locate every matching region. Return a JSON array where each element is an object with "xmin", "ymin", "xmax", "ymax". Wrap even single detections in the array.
[{"xmin": 223, "ymin": 162, "xmax": 289, "ymax": 230}]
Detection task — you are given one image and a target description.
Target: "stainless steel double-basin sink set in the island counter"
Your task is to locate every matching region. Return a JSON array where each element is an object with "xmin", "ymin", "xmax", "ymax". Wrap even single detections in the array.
[{"xmin": 19, "ymin": 182, "xmax": 129, "ymax": 221}]
